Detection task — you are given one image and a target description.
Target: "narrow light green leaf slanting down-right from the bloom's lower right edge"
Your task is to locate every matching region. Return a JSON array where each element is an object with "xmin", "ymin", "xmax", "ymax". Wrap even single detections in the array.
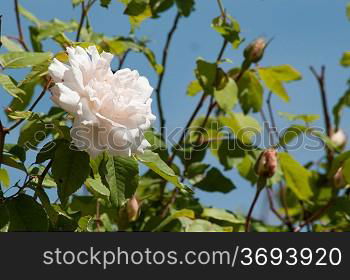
[{"xmin": 137, "ymin": 150, "xmax": 192, "ymax": 193}]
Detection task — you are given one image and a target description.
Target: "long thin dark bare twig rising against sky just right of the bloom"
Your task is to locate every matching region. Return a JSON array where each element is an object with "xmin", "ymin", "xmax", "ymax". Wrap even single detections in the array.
[{"xmin": 155, "ymin": 13, "xmax": 181, "ymax": 138}]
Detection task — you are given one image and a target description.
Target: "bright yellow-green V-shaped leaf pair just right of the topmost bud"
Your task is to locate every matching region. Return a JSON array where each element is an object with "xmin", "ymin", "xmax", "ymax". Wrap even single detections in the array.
[{"xmin": 258, "ymin": 65, "xmax": 301, "ymax": 102}]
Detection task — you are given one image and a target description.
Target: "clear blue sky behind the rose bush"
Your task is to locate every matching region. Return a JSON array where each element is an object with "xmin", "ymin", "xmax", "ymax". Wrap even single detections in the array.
[{"xmin": 0, "ymin": 0, "xmax": 350, "ymax": 223}]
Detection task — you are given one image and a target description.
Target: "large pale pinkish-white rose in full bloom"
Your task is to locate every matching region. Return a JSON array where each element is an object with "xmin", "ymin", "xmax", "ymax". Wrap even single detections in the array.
[{"xmin": 49, "ymin": 46, "xmax": 155, "ymax": 157}]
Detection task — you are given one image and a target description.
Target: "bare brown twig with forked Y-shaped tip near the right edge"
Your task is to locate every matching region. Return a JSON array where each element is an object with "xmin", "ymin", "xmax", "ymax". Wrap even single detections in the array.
[{"xmin": 310, "ymin": 65, "xmax": 333, "ymax": 163}]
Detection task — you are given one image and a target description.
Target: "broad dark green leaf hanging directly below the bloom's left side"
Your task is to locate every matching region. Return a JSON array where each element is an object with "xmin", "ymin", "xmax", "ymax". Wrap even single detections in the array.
[{"xmin": 52, "ymin": 144, "xmax": 90, "ymax": 205}]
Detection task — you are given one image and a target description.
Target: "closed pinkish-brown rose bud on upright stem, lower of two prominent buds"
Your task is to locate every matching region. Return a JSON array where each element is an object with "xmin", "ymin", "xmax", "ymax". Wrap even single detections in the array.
[{"xmin": 255, "ymin": 149, "xmax": 278, "ymax": 178}]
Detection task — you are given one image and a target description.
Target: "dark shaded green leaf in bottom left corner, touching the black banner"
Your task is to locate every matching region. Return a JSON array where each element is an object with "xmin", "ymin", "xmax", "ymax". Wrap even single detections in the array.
[{"xmin": 5, "ymin": 195, "xmax": 49, "ymax": 231}]
